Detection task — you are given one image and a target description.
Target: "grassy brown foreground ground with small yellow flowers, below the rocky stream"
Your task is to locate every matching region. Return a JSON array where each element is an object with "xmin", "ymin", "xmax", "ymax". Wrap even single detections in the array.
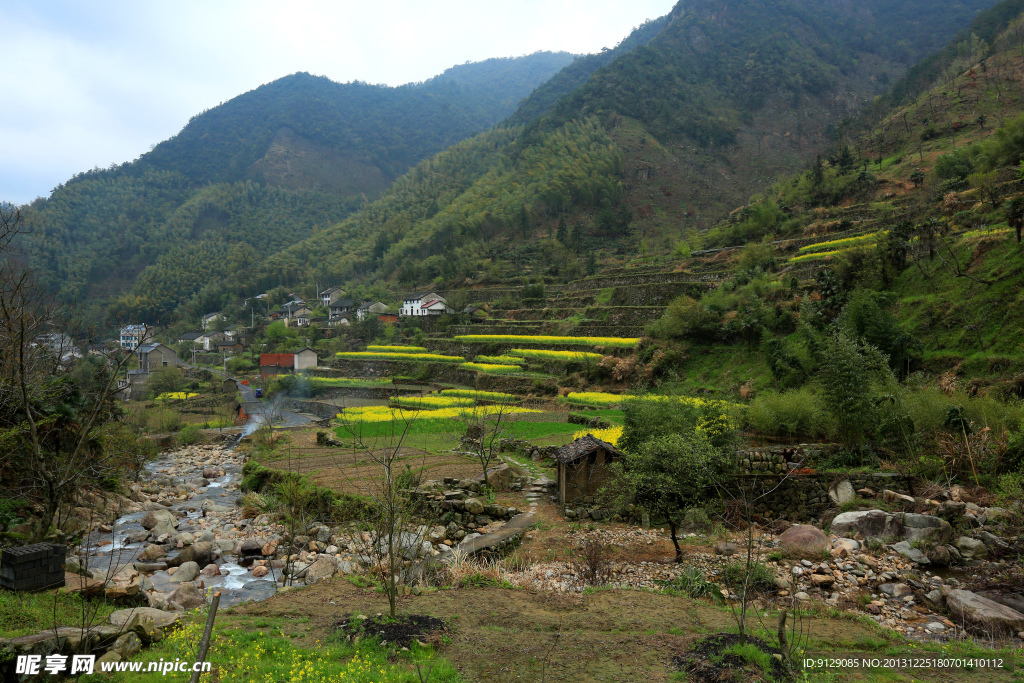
[{"xmin": 92, "ymin": 579, "xmax": 1020, "ymax": 683}]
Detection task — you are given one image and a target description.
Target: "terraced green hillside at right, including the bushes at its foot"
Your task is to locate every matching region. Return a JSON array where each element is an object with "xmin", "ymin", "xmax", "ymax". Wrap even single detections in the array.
[{"xmin": 651, "ymin": 12, "xmax": 1024, "ymax": 475}]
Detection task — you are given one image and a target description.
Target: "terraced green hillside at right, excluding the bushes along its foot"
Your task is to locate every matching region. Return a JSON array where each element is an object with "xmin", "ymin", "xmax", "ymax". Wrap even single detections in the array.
[{"xmin": 652, "ymin": 3, "xmax": 1024, "ymax": 401}]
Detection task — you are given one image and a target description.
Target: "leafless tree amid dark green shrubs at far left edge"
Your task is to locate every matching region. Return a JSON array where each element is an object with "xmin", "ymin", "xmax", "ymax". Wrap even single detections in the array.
[{"xmin": 0, "ymin": 207, "xmax": 149, "ymax": 541}]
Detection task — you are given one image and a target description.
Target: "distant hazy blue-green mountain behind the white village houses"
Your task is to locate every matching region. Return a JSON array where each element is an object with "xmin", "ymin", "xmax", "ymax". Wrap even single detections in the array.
[{"xmin": 19, "ymin": 52, "xmax": 573, "ymax": 318}]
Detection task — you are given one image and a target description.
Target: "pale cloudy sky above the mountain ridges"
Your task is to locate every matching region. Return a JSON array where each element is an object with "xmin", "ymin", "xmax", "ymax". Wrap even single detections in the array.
[{"xmin": 0, "ymin": 0, "xmax": 675, "ymax": 204}]
